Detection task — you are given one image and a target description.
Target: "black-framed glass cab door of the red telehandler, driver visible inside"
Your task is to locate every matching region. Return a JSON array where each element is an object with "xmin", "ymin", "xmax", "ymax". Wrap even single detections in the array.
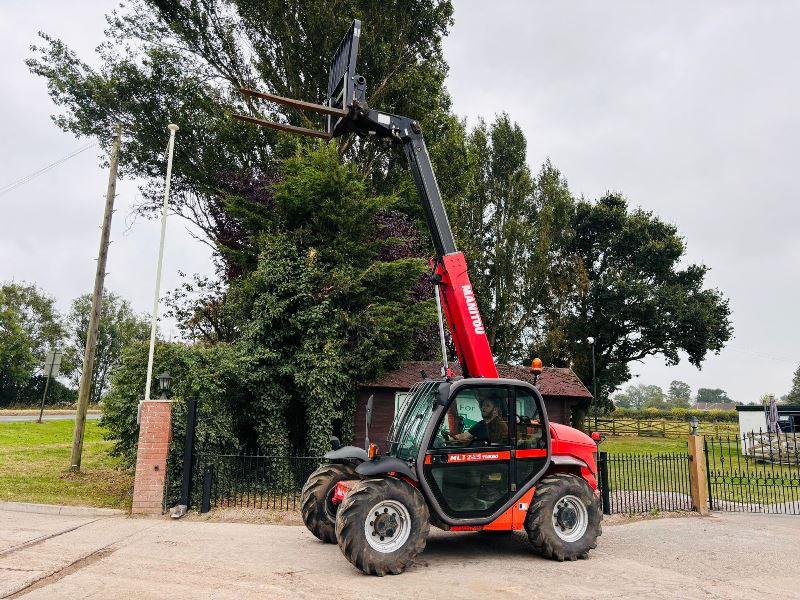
[{"xmin": 423, "ymin": 385, "xmax": 514, "ymax": 519}]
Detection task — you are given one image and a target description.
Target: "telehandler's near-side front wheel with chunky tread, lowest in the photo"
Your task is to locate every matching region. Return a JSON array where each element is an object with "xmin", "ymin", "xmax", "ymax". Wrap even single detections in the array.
[{"xmin": 336, "ymin": 477, "xmax": 431, "ymax": 577}]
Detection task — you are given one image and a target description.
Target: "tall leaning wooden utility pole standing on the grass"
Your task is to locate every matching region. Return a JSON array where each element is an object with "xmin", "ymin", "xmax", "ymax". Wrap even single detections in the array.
[{"xmin": 70, "ymin": 123, "xmax": 122, "ymax": 471}]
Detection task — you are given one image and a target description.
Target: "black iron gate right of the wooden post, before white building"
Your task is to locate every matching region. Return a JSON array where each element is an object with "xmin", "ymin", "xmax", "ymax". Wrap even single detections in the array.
[{"xmin": 705, "ymin": 430, "xmax": 800, "ymax": 515}]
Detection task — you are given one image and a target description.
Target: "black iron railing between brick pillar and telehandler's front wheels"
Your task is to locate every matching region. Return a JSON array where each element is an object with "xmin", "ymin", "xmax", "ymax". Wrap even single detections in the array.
[{"xmin": 191, "ymin": 453, "xmax": 322, "ymax": 512}]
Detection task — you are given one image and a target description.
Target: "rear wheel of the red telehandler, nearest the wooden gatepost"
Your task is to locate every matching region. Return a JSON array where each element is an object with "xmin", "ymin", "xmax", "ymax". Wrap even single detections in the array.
[{"xmin": 525, "ymin": 473, "xmax": 603, "ymax": 560}]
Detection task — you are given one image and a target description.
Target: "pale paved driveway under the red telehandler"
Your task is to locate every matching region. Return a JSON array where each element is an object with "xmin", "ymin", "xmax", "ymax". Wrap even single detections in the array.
[{"xmin": 0, "ymin": 511, "xmax": 800, "ymax": 600}]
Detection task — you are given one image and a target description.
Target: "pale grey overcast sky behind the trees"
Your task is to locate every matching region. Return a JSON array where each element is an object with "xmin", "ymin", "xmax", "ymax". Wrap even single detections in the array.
[{"xmin": 0, "ymin": 0, "xmax": 800, "ymax": 402}]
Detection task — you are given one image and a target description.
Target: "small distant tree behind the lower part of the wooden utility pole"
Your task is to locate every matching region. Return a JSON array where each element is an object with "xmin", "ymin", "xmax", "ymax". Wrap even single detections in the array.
[{"xmin": 65, "ymin": 291, "xmax": 150, "ymax": 404}]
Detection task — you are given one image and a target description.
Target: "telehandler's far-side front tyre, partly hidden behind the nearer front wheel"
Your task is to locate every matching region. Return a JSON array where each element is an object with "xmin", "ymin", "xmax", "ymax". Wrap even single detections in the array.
[{"xmin": 300, "ymin": 464, "xmax": 359, "ymax": 544}]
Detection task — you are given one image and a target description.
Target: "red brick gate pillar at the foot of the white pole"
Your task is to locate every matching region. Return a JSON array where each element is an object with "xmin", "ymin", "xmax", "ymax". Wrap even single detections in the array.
[{"xmin": 131, "ymin": 400, "xmax": 172, "ymax": 515}]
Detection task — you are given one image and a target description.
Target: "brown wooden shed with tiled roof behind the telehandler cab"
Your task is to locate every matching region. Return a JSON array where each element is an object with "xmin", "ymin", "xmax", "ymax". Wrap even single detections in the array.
[{"xmin": 353, "ymin": 361, "xmax": 592, "ymax": 446}]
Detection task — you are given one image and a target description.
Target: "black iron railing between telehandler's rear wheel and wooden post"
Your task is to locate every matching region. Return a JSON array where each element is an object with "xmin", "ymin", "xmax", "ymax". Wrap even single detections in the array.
[{"xmin": 599, "ymin": 452, "xmax": 692, "ymax": 514}]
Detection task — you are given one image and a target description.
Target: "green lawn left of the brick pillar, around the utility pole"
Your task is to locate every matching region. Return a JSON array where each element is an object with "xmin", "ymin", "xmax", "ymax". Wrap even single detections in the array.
[{"xmin": 0, "ymin": 421, "xmax": 133, "ymax": 508}]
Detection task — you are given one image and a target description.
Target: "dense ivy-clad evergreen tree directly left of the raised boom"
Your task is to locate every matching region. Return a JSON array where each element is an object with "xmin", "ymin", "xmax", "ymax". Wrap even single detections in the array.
[{"xmin": 227, "ymin": 148, "xmax": 435, "ymax": 454}]
